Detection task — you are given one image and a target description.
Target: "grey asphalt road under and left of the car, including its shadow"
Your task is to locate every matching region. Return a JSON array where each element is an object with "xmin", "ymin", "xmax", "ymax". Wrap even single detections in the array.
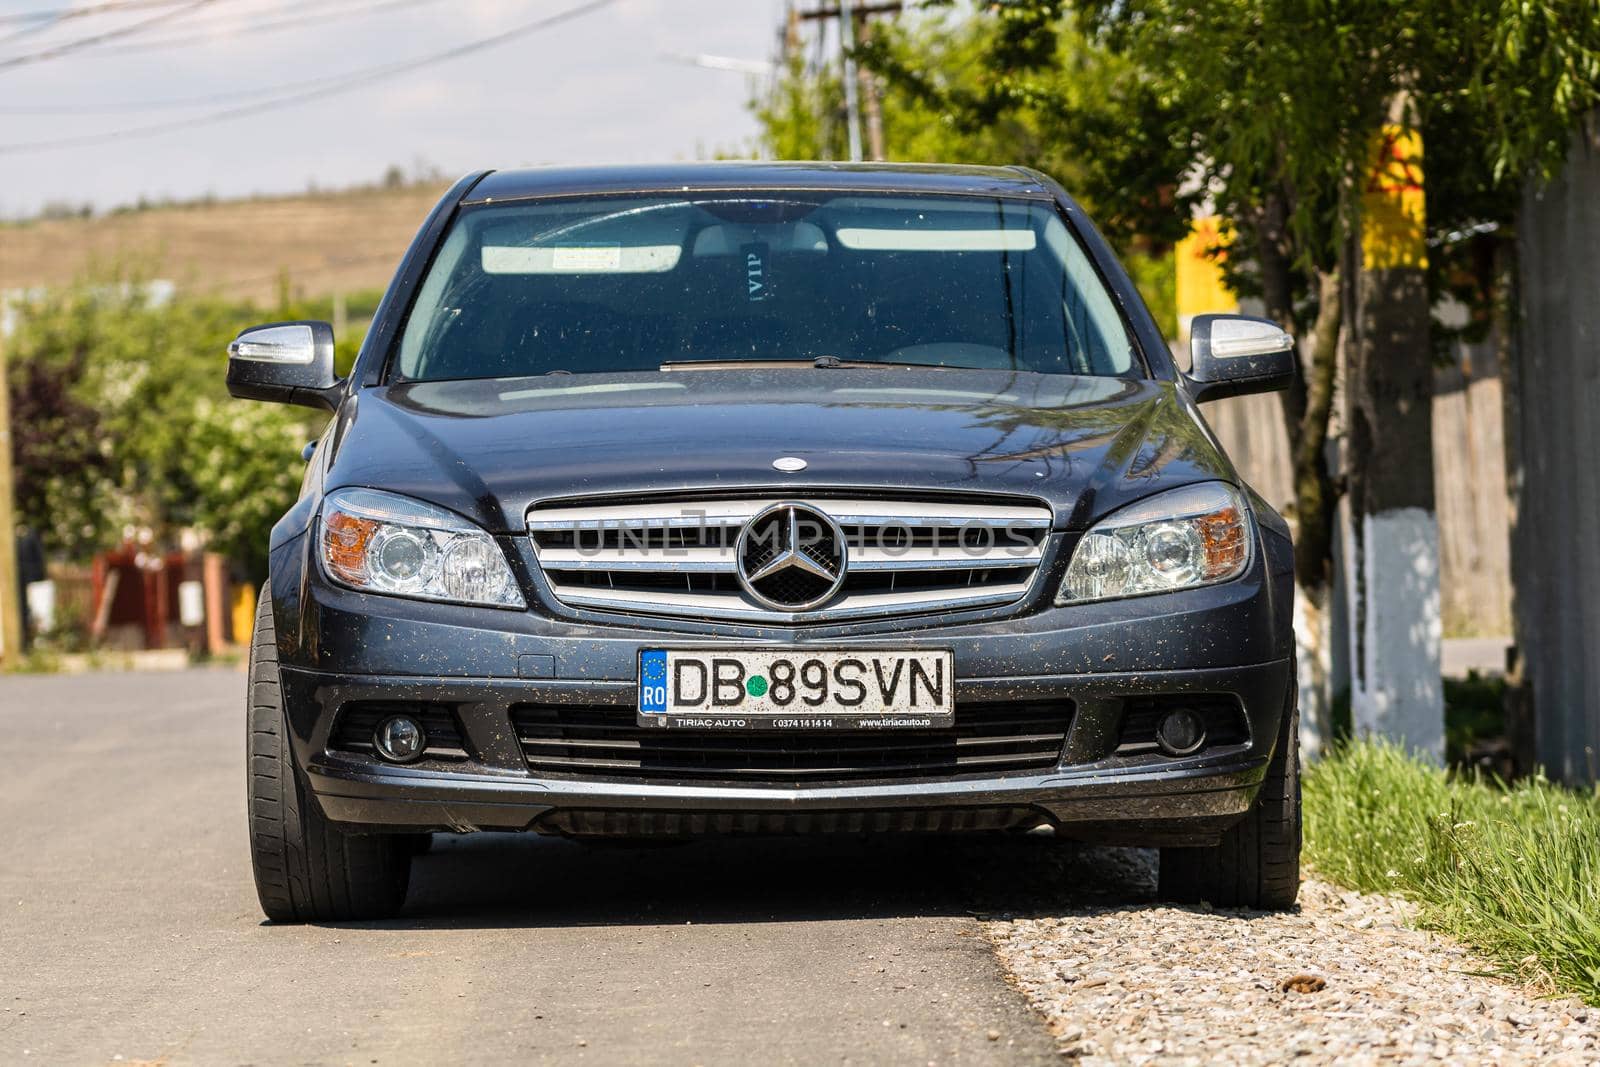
[{"xmin": 0, "ymin": 670, "xmax": 1100, "ymax": 1064}]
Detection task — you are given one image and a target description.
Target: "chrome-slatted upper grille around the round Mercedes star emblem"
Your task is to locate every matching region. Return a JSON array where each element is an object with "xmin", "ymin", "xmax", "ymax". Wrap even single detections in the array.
[{"xmin": 528, "ymin": 494, "xmax": 1051, "ymax": 624}]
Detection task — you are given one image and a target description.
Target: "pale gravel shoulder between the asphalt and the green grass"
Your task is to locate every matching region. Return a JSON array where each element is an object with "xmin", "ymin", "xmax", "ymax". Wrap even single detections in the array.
[{"xmin": 986, "ymin": 849, "xmax": 1600, "ymax": 1065}]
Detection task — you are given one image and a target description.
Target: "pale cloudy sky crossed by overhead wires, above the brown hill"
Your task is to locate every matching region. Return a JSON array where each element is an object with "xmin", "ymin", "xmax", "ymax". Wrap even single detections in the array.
[{"xmin": 0, "ymin": 0, "xmax": 784, "ymax": 218}]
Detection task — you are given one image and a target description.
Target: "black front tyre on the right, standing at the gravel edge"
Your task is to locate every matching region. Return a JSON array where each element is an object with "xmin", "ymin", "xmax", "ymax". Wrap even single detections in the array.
[{"xmin": 1158, "ymin": 683, "xmax": 1301, "ymax": 912}]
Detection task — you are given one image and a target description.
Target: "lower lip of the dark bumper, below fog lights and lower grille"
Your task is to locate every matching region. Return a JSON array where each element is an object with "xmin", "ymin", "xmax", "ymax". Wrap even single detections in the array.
[{"xmin": 309, "ymin": 726, "xmax": 1266, "ymax": 845}]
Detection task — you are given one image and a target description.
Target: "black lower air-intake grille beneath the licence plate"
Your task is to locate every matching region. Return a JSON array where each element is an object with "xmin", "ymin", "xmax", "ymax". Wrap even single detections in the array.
[{"xmin": 510, "ymin": 702, "xmax": 1072, "ymax": 785}]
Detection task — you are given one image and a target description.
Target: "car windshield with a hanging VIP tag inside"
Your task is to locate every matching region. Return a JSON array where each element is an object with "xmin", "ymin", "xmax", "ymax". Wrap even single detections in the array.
[{"xmin": 397, "ymin": 192, "xmax": 1134, "ymax": 381}]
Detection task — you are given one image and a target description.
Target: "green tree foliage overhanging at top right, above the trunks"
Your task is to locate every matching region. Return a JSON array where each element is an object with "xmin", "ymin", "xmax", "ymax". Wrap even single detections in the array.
[{"xmin": 758, "ymin": 0, "xmax": 1600, "ymax": 321}]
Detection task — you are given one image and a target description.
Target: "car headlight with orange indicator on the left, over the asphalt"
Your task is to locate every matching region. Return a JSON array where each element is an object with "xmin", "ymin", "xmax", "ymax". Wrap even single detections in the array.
[{"xmin": 318, "ymin": 490, "xmax": 526, "ymax": 608}]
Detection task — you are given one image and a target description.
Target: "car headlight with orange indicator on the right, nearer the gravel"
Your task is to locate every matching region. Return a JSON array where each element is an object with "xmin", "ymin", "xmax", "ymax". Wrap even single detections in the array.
[{"xmin": 1056, "ymin": 482, "xmax": 1254, "ymax": 605}]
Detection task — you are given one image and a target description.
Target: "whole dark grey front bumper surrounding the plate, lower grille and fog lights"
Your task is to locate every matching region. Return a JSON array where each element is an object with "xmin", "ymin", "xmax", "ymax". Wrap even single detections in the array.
[{"xmin": 274, "ymin": 537, "xmax": 1293, "ymax": 845}]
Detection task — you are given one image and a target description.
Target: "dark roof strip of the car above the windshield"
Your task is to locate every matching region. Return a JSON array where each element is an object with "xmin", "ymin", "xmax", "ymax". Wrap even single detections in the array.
[{"xmin": 462, "ymin": 162, "xmax": 1051, "ymax": 203}]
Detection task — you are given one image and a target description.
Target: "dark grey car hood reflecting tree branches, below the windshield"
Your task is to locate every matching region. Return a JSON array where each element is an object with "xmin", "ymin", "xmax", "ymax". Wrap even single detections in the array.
[{"xmin": 325, "ymin": 368, "xmax": 1237, "ymax": 533}]
